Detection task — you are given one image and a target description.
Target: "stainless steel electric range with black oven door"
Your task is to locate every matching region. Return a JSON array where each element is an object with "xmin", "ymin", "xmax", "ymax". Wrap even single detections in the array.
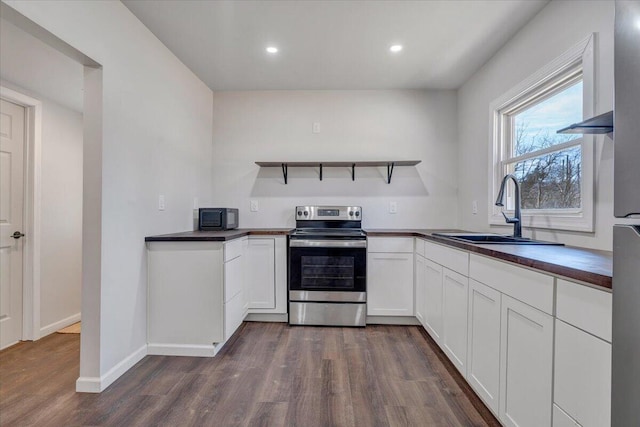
[{"xmin": 289, "ymin": 206, "xmax": 367, "ymax": 326}]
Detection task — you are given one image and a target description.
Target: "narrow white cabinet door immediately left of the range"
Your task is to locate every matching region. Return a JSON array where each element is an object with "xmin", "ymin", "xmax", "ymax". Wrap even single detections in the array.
[{"xmin": 246, "ymin": 238, "xmax": 276, "ymax": 309}]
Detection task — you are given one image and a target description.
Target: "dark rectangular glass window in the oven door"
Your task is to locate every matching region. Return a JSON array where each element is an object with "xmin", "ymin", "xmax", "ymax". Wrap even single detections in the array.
[{"xmin": 300, "ymin": 255, "xmax": 355, "ymax": 289}]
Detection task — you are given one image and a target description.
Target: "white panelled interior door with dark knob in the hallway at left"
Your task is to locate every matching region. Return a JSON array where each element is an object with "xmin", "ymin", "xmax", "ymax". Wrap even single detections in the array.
[{"xmin": 0, "ymin": 99, "xmax": 25, "ymax": 349}]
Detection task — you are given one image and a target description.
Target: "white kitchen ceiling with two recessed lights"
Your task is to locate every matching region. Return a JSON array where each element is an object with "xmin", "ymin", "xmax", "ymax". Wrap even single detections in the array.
[{"xmin": 123, "ymin": 0, "xmax": 548, "ymax": 90}]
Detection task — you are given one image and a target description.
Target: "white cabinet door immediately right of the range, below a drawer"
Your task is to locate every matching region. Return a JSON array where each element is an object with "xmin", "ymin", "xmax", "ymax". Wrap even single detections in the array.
[{"xmin": 367, "ymin": 253, "xmax": 414, "ymax": 316}]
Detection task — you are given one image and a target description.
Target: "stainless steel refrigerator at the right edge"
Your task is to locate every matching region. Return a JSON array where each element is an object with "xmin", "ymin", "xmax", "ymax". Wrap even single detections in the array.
[{"xmin": 611, "ymin": 0, "xmax": 640, "ymax": 427}]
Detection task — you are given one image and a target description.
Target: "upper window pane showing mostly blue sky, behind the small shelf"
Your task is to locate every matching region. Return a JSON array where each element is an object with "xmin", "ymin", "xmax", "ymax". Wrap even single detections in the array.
[{"xmin": 513, "ymin": 81, "xmax": 582, "ymax": 156}]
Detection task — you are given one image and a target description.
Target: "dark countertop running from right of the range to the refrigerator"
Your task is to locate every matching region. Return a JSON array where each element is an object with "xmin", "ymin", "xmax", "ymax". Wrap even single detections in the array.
[{"xmin": 367, "ymin": 229, "xmax": 613, "ymax": 289}]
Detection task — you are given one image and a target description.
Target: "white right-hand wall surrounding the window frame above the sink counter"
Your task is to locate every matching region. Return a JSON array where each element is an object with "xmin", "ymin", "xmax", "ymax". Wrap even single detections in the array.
[{"xmin": 458, "ymin": 0, "xmax": 614, "ymax": 250}]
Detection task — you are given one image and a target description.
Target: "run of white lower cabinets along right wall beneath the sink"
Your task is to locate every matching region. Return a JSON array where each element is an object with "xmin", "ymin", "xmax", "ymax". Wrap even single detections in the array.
[{"xmin": 410, "ymin": 242, "xmax": 612, "ymax": 427}]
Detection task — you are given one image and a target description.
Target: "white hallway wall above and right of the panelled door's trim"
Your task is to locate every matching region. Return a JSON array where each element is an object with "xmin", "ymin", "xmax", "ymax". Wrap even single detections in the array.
[{"xmin": 0, "ymin": 20, "xmax": 83, "ymax": 337}]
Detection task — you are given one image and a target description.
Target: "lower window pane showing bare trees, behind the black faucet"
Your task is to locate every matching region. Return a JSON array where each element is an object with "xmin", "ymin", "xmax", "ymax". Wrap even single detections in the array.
[{"xmin": 511, "ymin": 146, "xmax": 582, "ymax": 209}]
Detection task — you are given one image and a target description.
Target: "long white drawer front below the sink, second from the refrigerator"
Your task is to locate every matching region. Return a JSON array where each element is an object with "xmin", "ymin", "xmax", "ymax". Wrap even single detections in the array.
[{"xmin": 469, "ymin": 254, "xmax": 553, "ymax": 314}]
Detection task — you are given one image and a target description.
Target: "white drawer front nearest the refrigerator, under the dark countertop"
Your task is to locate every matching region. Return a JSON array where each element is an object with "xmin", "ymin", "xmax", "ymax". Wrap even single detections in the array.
[{"xmin": 556, "ymin": 279, "xmax": 612, "ymax": 342}]
